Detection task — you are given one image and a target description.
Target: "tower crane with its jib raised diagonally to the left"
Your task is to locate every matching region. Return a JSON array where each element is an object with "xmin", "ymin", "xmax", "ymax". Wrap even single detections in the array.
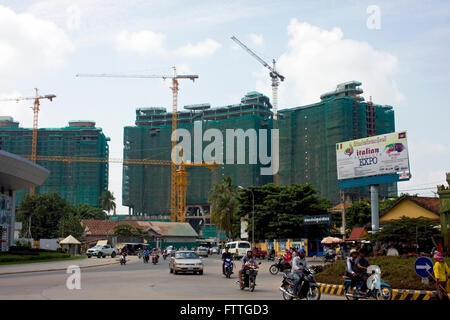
[{"xmin": 231, "ymin": 36, "xmax": 285, "ymax": 184}]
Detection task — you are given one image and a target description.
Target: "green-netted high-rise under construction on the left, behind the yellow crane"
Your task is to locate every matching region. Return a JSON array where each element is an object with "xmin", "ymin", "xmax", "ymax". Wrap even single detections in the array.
[{"xmin": 0, "ymin": 117, "xmax": 110, "ymax": 207}]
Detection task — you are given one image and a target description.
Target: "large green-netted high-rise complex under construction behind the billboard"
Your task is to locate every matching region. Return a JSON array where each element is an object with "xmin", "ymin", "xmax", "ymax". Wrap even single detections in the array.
[{"xmin": 122, "ymin": 81, "xmax": 397, "ymax": 225}]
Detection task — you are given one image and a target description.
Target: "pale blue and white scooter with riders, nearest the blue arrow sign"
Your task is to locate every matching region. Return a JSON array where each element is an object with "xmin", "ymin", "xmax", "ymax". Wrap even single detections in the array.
[{"xmin": 344, "ymin": 265, "xmax": 392, "ymax": 300}]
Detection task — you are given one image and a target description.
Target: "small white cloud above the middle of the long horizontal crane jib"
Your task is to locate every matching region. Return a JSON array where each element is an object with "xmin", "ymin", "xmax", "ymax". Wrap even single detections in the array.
[{"xmin": 116, "ymin": 30, "xmax": 166, "ymax": 55}]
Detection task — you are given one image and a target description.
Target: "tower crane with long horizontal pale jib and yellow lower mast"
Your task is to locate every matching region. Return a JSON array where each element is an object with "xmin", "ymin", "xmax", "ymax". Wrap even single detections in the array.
[{"xmin": 76, "ymin": 67, "xmax": 203, "ymax": 221}]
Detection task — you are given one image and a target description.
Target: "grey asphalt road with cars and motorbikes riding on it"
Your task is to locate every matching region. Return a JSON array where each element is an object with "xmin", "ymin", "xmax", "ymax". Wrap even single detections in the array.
[{"xmin": 0, "ymin": 255, "xmax": 343, "ymax": 300}]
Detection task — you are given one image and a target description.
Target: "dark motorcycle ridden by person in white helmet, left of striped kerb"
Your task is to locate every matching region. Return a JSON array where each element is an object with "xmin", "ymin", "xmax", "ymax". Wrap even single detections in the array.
[{"xmin": 280, "ymin": 267, "xmax": 320, "ymax": 300}]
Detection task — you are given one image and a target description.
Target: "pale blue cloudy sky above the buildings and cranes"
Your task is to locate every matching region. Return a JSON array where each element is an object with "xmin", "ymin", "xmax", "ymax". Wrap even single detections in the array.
[{"xmin": 0, "ymin": 0, "xmax": 450, "ymax": 213}]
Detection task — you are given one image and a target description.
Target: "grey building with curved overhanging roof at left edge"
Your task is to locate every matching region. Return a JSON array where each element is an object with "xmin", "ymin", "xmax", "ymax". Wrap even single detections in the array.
[{"xmin": 0, "ymin": 150, "xmax": 50, "ymax": 251}]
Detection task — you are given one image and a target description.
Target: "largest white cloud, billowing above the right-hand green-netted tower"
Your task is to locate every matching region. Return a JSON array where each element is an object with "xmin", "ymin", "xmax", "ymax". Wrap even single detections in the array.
[{"xmin": 257, "ymin": 19, "xmax": 404, "ymax": 109}]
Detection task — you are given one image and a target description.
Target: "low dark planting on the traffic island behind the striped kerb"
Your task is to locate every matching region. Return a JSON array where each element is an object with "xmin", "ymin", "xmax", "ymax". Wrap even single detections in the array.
[{"xmin": 315, "ymin": 257, "xmax": 450, "ymax": 290}]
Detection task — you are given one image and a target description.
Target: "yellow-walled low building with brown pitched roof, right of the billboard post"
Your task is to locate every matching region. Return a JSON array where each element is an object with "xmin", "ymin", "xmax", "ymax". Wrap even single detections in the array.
[{"xmin": 380, "ymin": 196, "xmax": 440, "ymax": 224}]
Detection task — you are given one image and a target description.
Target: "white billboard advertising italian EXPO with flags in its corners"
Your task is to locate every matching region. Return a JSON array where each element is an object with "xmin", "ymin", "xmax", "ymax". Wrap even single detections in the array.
[{"xmin": 336, "ymin": 131, "xmax": 410, "ymax": 181}]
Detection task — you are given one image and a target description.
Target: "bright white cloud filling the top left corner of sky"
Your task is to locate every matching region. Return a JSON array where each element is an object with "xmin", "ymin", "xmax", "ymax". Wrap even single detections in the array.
[{"xmin": 0, "ymin": 6, "xmax": 74, "ymax": 74}]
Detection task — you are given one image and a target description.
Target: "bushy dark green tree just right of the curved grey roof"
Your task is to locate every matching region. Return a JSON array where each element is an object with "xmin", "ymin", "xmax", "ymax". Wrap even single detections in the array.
[{"xmin": 17, "ymin": 193, "xmax": 73, "ymax": 240}]
